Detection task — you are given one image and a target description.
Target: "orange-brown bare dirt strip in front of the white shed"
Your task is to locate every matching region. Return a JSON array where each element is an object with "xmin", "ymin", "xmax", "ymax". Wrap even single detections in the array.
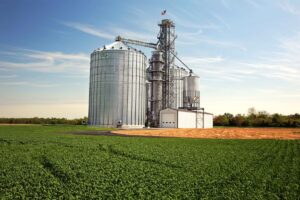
[{"xmin": 111, "ymin": 128, "xmax": 300, "ymax": 140}]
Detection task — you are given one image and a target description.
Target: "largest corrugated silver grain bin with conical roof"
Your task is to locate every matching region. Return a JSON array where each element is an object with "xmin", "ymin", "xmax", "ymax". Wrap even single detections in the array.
[{"xmin": 89, "ymin": 42, "xmax": 147, "ymax": 128}]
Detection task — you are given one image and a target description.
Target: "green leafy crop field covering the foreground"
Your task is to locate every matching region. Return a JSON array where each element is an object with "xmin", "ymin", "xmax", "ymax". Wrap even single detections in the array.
[{"xmin": 0, "ymin": 125, "xmax": 300, "ymax": 199}]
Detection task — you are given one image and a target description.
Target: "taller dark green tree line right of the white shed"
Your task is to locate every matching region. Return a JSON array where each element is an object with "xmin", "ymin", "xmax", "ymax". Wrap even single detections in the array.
[{"xmin": 214, "ymin": 108, "xmax": 300, "ymax": 127}]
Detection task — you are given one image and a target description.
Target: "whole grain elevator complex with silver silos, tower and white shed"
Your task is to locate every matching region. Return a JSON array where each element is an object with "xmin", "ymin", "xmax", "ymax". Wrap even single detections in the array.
[{"xmin": 89, "ymin": 19, "xmax": 213, "ymax": 128}]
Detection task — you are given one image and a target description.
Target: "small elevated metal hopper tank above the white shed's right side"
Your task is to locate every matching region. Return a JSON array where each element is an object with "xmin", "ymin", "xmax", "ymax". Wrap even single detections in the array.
[{"xmin": 183, "ymin": 74, "xmax": 200, "ymax": 110}]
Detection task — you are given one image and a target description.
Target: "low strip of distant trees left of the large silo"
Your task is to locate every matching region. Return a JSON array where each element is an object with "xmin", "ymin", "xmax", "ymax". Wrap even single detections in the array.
[{"xmin": 0, "ymin": 117, "xmax": 87, "ymax": 125}]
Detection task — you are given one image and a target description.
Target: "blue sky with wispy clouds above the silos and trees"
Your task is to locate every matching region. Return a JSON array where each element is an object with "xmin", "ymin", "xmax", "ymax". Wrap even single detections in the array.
[{"xmin": 0, "ymin": 0, "xmax": 300, "ymax": 118}]
